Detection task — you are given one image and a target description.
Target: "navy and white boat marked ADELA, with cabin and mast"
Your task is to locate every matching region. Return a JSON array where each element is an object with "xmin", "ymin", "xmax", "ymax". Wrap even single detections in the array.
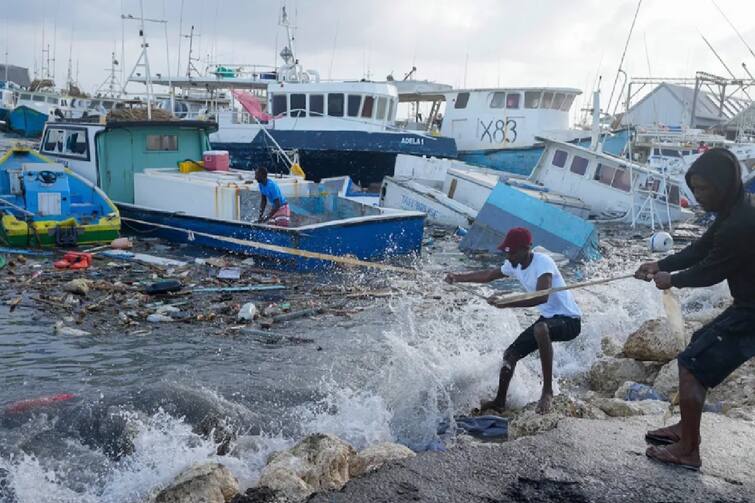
[{"xmin": 140, "ymin": 7, "xmax": 456, "ymax": 187}]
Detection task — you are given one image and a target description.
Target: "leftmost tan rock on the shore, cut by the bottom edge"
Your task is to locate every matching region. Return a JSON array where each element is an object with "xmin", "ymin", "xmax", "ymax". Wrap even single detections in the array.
[{"xmin": 155, "ymin": 463, "xmax": 239, "ymax": 503}]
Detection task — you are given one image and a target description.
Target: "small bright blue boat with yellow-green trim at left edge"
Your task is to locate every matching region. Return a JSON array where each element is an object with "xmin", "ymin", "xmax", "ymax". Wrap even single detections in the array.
[{"xmin": 0, "ymin": 146, "xmax": 121, "ymax": 246}]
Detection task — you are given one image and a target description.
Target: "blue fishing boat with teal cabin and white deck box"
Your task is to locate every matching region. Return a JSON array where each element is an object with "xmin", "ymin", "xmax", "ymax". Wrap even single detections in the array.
[{"xmin": 41, "ymin": 121, "xmax": 425, "ymax": 270}]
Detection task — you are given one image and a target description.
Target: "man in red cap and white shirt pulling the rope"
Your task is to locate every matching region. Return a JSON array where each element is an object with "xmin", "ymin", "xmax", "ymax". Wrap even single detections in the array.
[{"xmin": 446, "ymin": 227, "xmax": 582, "ymax": 414}]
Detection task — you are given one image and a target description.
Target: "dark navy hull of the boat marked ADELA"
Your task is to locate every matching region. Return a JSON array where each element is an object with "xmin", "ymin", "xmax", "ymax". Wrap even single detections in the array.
[{"xmin": 212, "ymin": 129, "xmax": 457, "ymax": 186}]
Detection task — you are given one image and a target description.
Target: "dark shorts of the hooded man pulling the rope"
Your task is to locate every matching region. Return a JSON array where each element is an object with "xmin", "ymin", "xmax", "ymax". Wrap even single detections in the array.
[{"xmin": 678, "ymin": 305, "xmax": 755, "ymax": 388}]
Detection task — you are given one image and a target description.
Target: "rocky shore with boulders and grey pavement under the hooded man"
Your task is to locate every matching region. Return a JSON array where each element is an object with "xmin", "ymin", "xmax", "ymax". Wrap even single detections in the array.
[{"xmin": 149, "ymin": 304, "xmax": 755, "ymax": 503}]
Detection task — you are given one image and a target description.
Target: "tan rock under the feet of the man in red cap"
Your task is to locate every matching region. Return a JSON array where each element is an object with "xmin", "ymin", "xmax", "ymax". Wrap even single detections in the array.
[{"xmin": 509, "ymin": 395, "xmax": 606, "ymax": 440}]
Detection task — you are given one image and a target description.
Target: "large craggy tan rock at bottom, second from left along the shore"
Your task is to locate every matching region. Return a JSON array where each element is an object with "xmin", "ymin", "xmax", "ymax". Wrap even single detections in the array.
[{"xmin": 259, "ymin": 433, "xmax": 356, "ymax": 501}]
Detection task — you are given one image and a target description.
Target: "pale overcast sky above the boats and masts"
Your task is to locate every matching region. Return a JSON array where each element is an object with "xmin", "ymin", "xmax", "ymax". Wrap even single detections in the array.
[{"xmin": 0, "ymin": 0, "xmax": 755, "ymax": 116}]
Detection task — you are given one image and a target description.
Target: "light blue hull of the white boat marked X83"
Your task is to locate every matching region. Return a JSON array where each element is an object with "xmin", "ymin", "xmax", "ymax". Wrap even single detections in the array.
[{"xmin": 459, "ymin": 130, "xmax": 629, "ymax": 176}]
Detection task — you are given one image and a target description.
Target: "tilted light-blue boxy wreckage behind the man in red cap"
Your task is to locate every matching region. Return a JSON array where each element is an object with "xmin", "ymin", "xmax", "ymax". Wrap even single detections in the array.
[{"xmin": 459, "ymin": 183, "xmax": 600, "ymax": 260}]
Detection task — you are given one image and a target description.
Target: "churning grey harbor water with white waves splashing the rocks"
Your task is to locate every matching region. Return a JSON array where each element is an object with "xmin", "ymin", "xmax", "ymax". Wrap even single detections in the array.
[{"xmin": 0, "ymin": 131, "xmax": 727, "ymax": 503}]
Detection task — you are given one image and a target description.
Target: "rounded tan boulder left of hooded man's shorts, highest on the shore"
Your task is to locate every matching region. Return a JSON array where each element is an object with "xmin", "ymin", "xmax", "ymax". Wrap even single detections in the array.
[{"xmin": 622, "ymin": 318, "xmax": 687, "ymax": 363}]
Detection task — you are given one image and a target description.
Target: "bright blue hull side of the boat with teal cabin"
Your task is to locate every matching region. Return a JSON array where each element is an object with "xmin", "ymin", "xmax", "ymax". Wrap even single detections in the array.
[{"xmin": 118, "ymin": 203, "xmax": 424, "ymax": 271}]
